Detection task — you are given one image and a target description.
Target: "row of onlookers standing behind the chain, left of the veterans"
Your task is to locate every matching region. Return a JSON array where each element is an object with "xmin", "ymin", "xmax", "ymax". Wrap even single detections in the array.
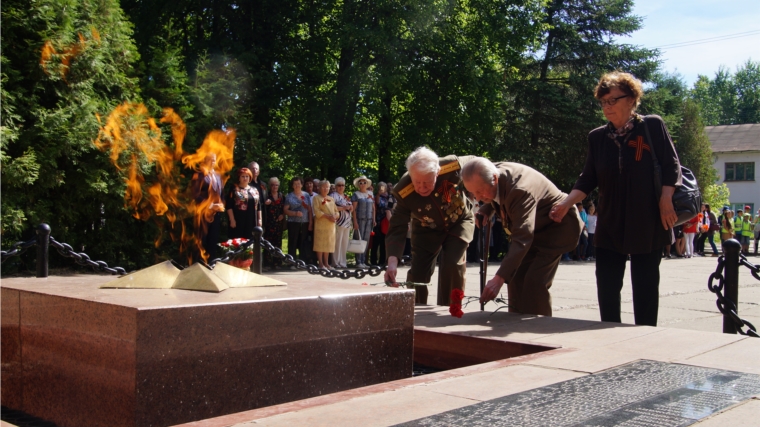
[{"xmin": 194, "ymin": 159, "xmax": 404, "ymax": 270}]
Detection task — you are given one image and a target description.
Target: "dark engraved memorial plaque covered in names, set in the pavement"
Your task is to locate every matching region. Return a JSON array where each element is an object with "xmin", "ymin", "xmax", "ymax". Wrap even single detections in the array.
[{"xmin": 399, "ymin": 360, "xmax": 760, "ymax": 427}]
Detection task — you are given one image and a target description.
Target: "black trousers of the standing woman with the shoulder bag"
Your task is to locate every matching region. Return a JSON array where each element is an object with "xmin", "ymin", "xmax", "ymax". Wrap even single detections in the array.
[{"xmin": 596, "ymin": 248, "xmax": 662, "ymax": 326}]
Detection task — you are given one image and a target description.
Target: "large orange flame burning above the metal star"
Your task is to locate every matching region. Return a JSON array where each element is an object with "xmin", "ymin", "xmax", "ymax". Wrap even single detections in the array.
[{"xmin": 93, "ymin": 102, "xmax": 235, "ymax": 263}]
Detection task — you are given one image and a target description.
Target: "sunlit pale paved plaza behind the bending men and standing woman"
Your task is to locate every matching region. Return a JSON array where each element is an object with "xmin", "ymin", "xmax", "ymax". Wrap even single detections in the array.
[{"xmin": 267, "ymin": 256, "xmax": 760, "ymax": 332}]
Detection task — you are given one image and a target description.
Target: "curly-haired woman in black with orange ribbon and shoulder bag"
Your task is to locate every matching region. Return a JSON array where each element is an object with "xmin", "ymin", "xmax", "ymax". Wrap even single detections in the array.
[{"xmin": 551, "ymin": 71, "xmax": 681, "ymax": 326}]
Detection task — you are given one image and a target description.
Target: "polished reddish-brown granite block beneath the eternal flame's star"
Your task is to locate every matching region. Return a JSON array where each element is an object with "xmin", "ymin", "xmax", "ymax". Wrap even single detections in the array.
[{"xmin": 2, "ymin": 276, "xmax": 414, "ymax": 427}]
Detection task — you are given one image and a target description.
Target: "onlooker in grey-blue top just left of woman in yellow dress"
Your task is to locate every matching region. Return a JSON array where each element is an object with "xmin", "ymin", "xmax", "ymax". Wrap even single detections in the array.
[{"xmin": 283, "ymin": 176, "xmax": 313, "ymax": 269}]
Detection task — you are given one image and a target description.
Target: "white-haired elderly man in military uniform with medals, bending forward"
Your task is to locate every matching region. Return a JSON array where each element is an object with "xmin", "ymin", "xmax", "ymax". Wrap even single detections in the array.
[{"xmin": 385, "ymin": 147, "xmax": 475, "ymax": 305}]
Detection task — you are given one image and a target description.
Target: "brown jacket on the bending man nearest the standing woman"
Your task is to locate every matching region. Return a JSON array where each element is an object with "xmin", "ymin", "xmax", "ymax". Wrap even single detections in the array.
[{"xmin": 479, "ymin": 162, "xmax": 583, "ymax": 283}]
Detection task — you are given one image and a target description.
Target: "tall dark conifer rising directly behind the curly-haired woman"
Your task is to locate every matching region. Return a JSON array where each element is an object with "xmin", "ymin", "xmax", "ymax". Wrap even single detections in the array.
[{"xmin": 492, "ymin": 0, "xmax": 657, "ymax": 189}]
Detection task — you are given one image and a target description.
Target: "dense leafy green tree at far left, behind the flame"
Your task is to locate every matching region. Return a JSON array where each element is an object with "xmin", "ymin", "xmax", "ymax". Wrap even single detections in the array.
[{"xmin": 1, "ymin": 0, "xmax": 152, "ymax": 267}]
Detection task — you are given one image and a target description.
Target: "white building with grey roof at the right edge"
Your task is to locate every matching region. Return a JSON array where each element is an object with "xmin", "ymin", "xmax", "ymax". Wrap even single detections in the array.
[{"xmin": 705, "ymin": 123, "xmax": 760, "ymax": 218}]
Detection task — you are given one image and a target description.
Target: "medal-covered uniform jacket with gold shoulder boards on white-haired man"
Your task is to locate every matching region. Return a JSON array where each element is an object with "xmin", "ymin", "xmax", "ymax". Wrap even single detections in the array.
[{"xmin": 385, "ymin": 156, "xmax": 475, "ymax": 258}]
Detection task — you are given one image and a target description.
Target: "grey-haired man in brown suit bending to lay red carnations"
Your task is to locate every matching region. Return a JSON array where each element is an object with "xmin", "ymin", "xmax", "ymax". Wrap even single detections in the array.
[{"xmin": 462, "ymin": 157, "xmax": 583, "ymax": 316}]
